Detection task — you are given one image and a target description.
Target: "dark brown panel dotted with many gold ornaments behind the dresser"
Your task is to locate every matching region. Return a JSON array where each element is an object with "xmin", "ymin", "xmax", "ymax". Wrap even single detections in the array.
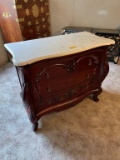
[{"xmin": 15, "ymin": 0, "xmax": 50, "ymax": 40}]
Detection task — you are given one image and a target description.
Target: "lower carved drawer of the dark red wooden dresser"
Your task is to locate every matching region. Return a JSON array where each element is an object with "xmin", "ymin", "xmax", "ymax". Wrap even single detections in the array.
[{"xmin": 32, "ymin": 68, "xmax": 98, "ymax": 112}]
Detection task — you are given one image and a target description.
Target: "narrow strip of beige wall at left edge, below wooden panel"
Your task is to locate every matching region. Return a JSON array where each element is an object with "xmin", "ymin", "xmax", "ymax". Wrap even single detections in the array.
[{"xmin": 0, "ymin": 31, "xmax": 8, "ymax": 66}]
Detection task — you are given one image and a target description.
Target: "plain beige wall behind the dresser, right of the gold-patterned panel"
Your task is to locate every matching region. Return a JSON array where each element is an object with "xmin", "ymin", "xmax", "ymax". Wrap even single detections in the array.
[{"xmin": 49, "ymin": 0, "xmax": 120, "ymax": 35}]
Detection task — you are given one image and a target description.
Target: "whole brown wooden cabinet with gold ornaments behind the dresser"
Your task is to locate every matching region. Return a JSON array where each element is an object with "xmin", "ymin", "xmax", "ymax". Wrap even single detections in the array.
[{"xmin": 0, "ymin": 0, "xmax": 50, "ymax": 43}]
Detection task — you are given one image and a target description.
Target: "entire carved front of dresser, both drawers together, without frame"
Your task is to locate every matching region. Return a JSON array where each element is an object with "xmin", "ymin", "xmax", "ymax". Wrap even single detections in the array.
[{"xmin": 30, "ymin": 48, "xmax": 102, "ymax": 112}]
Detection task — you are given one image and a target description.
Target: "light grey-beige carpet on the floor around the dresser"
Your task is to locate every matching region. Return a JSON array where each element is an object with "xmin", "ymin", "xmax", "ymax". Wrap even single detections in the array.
[{"xmin": 0, "ymin": 63, "xmax": 120, "ymax": 160}]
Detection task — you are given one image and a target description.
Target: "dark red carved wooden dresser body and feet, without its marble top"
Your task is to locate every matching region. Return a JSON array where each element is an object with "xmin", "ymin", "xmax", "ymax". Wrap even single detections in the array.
[{"xmin": 16, "ymin": 47, "xmax": 109, "ymax": 131}]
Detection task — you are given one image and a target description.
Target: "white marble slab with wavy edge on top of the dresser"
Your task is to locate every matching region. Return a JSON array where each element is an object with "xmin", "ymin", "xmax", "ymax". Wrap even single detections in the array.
[{"xmin": 4, "ymin": 32, "xmax": 115, "ymax": 66}]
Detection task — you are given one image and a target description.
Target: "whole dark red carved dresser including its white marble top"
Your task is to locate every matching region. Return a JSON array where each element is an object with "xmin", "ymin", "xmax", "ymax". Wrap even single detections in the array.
[{"xmin": 5, "ymin": 32, "xmax": 114, "ymax": 131}]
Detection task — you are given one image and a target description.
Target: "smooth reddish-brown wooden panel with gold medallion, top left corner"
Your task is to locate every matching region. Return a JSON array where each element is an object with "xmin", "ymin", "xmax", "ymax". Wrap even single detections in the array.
[{"xmin": 0, "ymin": 0, "xmax": 23, "ymax": 43}]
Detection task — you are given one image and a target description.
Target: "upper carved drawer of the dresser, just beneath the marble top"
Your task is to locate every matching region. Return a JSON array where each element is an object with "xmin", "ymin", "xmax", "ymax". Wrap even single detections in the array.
[{"xmin": 29, "ymin": 49, "xmax": 103, "ymax": 83}]
